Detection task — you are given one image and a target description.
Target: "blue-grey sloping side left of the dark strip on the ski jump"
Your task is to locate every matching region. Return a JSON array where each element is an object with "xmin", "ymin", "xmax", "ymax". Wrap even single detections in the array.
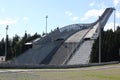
[{"xmin": 12, "ymin": 41, "xmax": 62, "ymax": 64}]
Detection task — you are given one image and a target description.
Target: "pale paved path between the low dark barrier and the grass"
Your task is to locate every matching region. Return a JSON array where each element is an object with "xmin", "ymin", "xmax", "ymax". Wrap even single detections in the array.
[{"xmin": 0, "ymin": 64, "xmax": 120, "ymax": 73}]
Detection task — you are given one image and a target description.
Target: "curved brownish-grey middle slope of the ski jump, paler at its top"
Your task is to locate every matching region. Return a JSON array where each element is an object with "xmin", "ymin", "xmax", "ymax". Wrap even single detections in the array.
[{"xmin": 49, "ymin": 29, "xmax": 89, "ymax": 65}]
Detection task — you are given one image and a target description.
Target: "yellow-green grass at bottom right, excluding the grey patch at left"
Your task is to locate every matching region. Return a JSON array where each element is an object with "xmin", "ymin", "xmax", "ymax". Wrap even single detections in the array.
[{"xmin": 37, "ymin": 69, "xmax": 120, "ymax": 80}]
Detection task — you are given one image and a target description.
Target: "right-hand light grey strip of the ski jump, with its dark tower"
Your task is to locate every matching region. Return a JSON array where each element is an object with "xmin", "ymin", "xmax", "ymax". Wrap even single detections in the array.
[{"xmin": 67, "ymin": 8, "xmax": 114, "ymax": 65}]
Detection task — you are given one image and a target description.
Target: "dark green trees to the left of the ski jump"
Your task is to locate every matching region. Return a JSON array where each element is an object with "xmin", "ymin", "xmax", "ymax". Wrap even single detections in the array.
[{"xmin": 0, "ymin": 33, "xmax": 41, "ymax": 60}]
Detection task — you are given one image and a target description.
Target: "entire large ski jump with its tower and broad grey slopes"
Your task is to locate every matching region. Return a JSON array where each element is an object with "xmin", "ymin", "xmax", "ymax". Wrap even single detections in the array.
[{"xmin": 11, "ymin": 8, "xmax": 114, "ymax": 65}]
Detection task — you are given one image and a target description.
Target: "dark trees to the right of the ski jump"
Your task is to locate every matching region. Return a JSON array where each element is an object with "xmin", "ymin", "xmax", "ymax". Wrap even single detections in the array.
[{"xmin": 90, "ymin": 26, "xmax": 120, "ymax": 63}]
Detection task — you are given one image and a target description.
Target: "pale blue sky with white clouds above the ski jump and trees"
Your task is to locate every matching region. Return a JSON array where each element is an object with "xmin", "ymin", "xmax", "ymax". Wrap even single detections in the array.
[{"xmin": 0, "ymin": 0, "xmax": 120, "ymax": 39}]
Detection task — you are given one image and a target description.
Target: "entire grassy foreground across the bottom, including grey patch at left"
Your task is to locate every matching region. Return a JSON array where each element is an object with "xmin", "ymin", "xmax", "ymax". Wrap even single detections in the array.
[{"xmin": 0, "ymin": 64, "xmax": 120, "ymax": 80}]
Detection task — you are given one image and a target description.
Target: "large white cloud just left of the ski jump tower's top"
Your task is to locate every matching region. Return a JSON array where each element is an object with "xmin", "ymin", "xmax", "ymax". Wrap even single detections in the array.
[{"xmin": 81, "ymin": 9, "xmax": 104, "ymax": 21}]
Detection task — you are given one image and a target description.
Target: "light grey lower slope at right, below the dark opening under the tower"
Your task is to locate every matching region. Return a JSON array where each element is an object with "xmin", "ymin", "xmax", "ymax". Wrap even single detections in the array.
[{"xmin": 67, "ymin": 40, "xmax": 94, "ymax": 65}]
